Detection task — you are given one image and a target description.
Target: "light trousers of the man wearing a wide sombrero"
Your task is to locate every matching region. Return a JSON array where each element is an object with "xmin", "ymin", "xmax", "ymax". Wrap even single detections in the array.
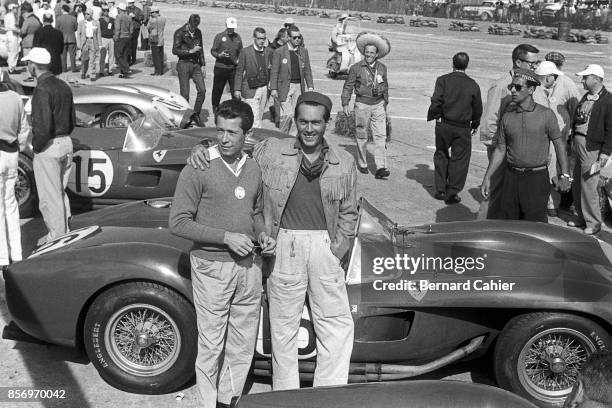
[{"xmin": 355, "ymin": 101, "xmax": 388, "ymax": 170}]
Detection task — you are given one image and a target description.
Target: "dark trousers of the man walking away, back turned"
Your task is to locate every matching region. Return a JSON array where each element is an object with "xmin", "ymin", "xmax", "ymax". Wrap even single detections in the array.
[{"xmin": 434, "ymin": 122, "xmax": 472, "ymax": 196}]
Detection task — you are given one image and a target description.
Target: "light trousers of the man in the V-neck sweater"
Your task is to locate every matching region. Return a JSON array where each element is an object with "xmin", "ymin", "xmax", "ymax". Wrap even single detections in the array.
[{"xmin": 191, "ymin": 254, "xmax": 262, "ymax": 408}]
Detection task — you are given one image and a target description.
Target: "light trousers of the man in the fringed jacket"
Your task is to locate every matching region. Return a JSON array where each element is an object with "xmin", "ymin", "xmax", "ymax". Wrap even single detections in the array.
[{"xmin": 267, "ymin": 229, "xmax": 354, "ymax": 391}]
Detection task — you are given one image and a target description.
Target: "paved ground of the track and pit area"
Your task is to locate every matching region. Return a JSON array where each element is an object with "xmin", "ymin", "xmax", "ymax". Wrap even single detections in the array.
[{"xmin": 0, "ymin": 4, "xmax": 612, "ymax": 408}]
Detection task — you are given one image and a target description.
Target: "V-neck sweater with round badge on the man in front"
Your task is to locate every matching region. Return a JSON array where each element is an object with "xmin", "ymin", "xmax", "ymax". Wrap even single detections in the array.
[{"xmin": 169, "ymin": 152, "xmax": 265, "ymax": 262}]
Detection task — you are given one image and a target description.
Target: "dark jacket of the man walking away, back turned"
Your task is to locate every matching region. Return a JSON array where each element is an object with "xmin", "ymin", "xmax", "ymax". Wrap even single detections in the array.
[{"xmin": 427, "ymin": 71, "xmax": 482, "ymax": 129}]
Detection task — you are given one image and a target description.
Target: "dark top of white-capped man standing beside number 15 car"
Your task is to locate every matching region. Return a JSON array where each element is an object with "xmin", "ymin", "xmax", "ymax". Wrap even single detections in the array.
[{"xmin": 32, "ymin": 73, "xmax": 76, "ymax": 153}]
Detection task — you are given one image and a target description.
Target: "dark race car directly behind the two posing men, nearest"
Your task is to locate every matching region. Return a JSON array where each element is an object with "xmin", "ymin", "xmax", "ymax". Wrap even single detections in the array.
[{"xmin": 4, "ymin": 198, "xmax": 612, "ymax": 407}]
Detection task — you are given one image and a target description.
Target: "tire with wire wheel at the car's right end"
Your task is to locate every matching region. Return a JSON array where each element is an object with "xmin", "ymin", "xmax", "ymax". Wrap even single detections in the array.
[{"xmin": 493, "ymin": 312, "xmax": 612, "ymax": 407}]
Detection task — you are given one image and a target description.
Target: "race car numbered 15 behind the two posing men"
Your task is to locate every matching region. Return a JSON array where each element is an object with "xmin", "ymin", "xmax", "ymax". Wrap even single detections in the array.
[{"xmin": 15, "ymin": 114, "xmax": 289, "ymax": 218}]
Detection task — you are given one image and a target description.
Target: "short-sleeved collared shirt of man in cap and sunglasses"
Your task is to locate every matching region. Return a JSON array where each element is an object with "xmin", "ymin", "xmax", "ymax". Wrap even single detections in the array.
[{"xmin": 494, "ymin": 101, "xmax": 561, "ymax": 168}]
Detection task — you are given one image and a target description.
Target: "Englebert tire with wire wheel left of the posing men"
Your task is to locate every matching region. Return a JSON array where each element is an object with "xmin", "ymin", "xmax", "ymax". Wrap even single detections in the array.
[{"xmin": 83, "ymin": 282, "xmax": 197, "ymax": 394}]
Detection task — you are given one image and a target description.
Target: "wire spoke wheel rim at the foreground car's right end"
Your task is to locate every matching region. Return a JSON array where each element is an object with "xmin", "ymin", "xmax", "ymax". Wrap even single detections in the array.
[{"xmin": 517, "ymin": 328, "xmax": 596, "ymax": 399}]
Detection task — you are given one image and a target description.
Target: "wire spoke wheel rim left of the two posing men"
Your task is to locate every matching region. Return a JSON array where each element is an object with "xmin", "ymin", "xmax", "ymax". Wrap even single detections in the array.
[{"xmin": 104, "ymin": 303, "xmax": 181, "ymax": 376}]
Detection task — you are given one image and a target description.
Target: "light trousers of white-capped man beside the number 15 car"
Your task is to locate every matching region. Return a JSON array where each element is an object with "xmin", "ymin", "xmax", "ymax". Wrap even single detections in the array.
[{"xmin": 33, "ymin": 136, "xmax": 72, "ymax": 243}]
